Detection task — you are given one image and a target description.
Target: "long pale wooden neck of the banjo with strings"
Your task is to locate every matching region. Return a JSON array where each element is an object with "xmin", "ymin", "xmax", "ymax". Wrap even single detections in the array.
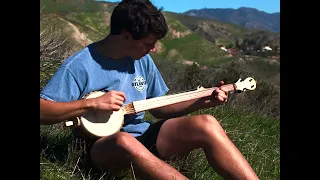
[{"xmin": 123, "ymin": 84, "xmax": 237, "ymax": 114}]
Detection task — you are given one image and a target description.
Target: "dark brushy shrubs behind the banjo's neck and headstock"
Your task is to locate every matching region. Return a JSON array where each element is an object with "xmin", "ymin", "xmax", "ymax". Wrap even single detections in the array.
[{"xmin": 155, "ymin": 60, "xmax": 280, "ymax": 118}]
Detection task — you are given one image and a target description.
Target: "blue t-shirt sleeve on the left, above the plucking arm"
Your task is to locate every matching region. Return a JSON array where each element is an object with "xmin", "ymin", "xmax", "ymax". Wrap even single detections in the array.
[{"xmin": 40, "ymin": 66, "xmax": 80, "ymax": 102}]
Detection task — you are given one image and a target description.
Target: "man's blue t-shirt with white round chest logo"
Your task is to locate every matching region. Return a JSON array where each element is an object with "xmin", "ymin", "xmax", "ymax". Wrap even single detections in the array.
[{"xmin": 40, "ymin": 44, "xmax": 168, "ymax": 137}]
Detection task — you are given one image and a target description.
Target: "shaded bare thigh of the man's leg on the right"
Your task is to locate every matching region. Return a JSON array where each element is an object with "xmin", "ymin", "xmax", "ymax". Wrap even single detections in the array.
[{"xmin": 156, "ymin": 115, "xmax": 216, "ymax": 159}]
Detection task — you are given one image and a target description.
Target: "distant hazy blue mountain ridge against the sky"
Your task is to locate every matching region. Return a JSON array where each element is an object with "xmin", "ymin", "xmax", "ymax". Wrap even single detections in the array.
[{"xmin": 182, "ymin": 7, "xmax": 280, "ymax": 32}]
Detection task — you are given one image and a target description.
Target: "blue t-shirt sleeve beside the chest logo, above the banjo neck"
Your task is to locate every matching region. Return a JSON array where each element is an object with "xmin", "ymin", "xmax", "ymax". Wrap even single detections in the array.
[{"xmin": 147, "ymin": 55, "xmax": 169, "ymax": 99}]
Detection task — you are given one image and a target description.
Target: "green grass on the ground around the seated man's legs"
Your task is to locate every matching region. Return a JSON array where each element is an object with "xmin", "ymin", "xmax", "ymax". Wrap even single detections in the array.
[{"xmin": 40, "ymin": 106, "xmax": 280, "ymax": 180}]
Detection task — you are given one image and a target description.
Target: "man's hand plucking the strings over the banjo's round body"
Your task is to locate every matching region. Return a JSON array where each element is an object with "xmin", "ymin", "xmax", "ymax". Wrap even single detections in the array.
[{"xmin": 92, "ymin": 90, "xmax": 126, "ymax": 111}]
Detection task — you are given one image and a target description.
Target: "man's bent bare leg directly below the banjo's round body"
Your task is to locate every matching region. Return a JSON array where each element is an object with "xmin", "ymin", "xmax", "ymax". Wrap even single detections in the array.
[{"xmin": 91, "ymin": 132, "xmax": 188, "ymax": 180}]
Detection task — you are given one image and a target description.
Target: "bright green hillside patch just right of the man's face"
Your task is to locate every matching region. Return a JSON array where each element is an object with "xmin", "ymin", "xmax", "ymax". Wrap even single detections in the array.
[{"xmin": 152, "ymin": 13, "xmax": 228, "ymax": 66}]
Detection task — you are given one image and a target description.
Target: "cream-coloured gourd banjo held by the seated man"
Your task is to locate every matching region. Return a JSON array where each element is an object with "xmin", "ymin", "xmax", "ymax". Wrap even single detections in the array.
[{"xmin": 65, "ymin": 77, "xmax": 256, "ymax": 137}]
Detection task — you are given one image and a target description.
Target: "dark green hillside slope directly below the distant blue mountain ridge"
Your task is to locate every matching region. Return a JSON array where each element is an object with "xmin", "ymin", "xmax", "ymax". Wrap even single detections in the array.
[{"xmin": 167, "ymin": 12, "xmax": 280, "ymax": 51}]
